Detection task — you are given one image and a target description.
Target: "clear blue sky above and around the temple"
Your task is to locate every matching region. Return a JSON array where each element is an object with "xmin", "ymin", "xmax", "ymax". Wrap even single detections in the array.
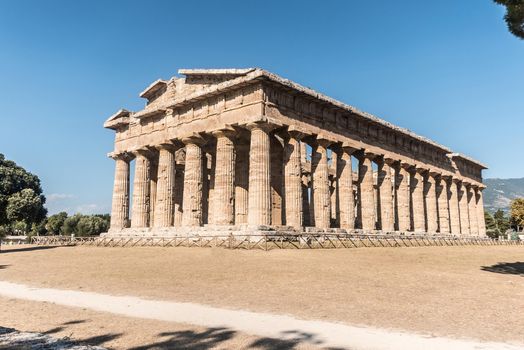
[{"xmin": 0, "ymin": 0, "xmax": 524, "ymax": 213}]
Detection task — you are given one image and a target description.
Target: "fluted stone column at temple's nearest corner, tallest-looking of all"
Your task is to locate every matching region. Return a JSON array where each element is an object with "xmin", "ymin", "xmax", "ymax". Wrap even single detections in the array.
[{"xmin": 248, "ymin": 124, "xmax": 271, "ymax": 225}]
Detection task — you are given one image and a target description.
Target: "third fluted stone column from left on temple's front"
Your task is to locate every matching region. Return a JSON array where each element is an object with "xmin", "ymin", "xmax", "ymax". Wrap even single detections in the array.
[{"xmin": 153, "ymin": 144, "xmax": 175, "ymax": 227}]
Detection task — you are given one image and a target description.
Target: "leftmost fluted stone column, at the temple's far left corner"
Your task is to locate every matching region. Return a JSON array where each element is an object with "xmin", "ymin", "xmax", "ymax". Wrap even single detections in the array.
[{"xmin": 110, "ymin": 153, "xmax": 131, "ymax": 231}]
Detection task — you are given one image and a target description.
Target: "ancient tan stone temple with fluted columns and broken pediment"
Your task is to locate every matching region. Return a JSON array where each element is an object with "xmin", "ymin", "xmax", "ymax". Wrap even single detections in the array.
[{"xmin": 104, "ymin": 69, "xmax": 486, "ymax": 236}]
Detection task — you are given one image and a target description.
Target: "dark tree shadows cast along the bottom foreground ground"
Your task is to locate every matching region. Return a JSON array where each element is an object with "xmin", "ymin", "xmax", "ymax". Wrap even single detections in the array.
[{"xmin": 0, "ymin": 320, "xmax": 348, "ymax": 350}]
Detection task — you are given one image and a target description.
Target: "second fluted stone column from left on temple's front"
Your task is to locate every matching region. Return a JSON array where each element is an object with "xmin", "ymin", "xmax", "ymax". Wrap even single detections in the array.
[{"xmin": 131, "ymin": 150, "xmax": 151, "ymax": 228}]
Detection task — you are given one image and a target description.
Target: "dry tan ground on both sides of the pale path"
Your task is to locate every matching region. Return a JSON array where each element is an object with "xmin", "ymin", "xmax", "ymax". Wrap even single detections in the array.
[{"xmin": 0, "ymin": 246, "xmax": 524, "ymax": 347}]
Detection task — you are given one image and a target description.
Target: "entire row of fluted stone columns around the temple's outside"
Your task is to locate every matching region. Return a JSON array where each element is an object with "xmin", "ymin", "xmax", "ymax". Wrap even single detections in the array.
[{"xmin": 111, "ymin": 124, "xmax": 485, "ymax": 235}]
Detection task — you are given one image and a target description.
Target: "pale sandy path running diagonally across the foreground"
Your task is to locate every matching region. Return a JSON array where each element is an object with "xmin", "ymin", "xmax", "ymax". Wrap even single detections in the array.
[{"xmin": 0, "ymin": 282, "xmax": 524, "ymax": 350}]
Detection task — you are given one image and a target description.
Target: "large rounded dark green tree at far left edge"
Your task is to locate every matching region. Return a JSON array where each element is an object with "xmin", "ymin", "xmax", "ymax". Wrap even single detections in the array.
[{"xmin": 0, "ymin": 153, "xmax": 47, "ymax": 233}]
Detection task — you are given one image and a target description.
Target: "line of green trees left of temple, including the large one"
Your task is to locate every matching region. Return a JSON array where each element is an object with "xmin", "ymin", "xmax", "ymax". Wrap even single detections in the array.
[{"xmin": 0, "ymin": 153, "xmax": 110, "ymax": 236}]
